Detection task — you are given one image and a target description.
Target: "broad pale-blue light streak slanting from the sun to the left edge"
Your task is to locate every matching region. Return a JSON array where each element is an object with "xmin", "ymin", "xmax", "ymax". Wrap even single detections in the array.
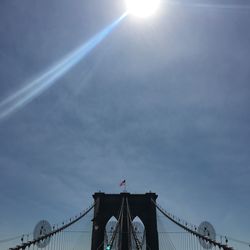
[{"xmin": 0, "ymin": 13, "xmax": 127, "ymax": 119}]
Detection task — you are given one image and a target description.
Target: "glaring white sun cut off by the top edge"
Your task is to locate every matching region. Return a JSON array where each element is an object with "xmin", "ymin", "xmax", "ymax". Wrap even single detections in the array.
[{"xmin": 125, "ymin": 0, "xmax": 160, "ymax": 17}]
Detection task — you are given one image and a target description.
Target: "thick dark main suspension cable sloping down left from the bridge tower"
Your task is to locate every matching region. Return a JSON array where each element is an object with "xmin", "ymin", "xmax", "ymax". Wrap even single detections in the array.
[{"xmin": 9, "ymin": 204, "xmax": 95, "ymax": 250}]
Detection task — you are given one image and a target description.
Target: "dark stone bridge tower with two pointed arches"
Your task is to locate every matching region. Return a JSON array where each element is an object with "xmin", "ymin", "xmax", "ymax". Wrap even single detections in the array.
[{"xmin": 91, "ymin": 192, "xmax": 159, "ymax": 250}]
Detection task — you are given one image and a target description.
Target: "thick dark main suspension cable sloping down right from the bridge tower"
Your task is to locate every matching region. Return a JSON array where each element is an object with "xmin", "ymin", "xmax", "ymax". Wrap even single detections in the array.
[{"xmin": 151, "ymin": 199, "xmax": 233, "ymax": 250}]
